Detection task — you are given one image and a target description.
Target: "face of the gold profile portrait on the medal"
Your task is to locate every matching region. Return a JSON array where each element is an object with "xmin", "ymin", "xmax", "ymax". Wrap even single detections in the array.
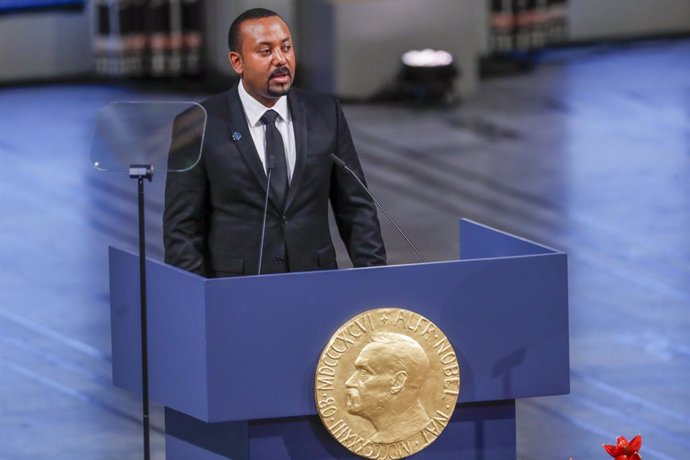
[{"xmin": 345, "ymin": 344, "xmax": 395, "ymax": 417}]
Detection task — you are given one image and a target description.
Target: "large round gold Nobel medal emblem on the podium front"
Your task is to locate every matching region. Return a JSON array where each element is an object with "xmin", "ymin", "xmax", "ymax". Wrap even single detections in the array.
[{"xmin": 314, "ymin": 308, "xmax": 460, "ymax": 460}]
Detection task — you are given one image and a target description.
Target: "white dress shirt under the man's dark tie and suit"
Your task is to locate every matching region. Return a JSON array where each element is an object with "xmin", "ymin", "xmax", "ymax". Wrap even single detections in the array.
[{"xmin": 237, "ymin": 80, "xmax": 297, "ymax": 181}]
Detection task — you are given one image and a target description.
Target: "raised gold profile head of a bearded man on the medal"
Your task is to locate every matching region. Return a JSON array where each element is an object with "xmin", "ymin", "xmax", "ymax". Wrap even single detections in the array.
[{"xmin": 345, "ymin": 332, "xmax": 431, "ymax": 444}]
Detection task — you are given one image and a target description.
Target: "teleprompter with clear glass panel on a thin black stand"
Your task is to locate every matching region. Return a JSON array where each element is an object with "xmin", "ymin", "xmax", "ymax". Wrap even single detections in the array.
[{"xmin": 91, "ymin": 101, "xmax": 206, "ymax": 460}]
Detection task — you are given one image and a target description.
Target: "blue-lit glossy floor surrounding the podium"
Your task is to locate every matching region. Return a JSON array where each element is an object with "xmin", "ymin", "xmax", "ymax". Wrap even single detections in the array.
[{"xmin": 0, "ymin": 40, "xmax": 690, "ymax": 460}]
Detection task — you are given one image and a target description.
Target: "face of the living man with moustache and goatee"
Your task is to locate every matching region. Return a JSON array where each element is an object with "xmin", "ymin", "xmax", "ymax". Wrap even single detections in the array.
[{"xmin": 228, "ymin": 16, "xmax": 295, "ymax": 107}]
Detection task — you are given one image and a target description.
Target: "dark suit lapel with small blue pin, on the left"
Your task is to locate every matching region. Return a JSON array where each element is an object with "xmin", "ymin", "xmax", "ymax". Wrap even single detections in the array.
[{"xmin": 226, "ymin": 86, "xmax": 266, "ymax": 197}]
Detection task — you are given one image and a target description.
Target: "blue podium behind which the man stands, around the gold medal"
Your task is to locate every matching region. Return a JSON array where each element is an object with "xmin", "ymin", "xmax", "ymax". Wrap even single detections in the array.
[{"xmin": 110, "ymin": 220, "xmax": 570, "ymax": 460}]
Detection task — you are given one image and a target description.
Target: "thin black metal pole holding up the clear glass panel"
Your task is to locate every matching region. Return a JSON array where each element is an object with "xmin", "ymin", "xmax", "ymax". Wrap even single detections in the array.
[{"xmin": 129, "ymin": 165, "xmax": 153, "ymax": 460}]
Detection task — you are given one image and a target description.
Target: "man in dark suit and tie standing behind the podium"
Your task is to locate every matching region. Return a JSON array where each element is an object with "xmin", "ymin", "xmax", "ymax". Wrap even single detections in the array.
[{"xmin": 164, "ymin": 9, "xmax": 386, "ymax": 277}]
